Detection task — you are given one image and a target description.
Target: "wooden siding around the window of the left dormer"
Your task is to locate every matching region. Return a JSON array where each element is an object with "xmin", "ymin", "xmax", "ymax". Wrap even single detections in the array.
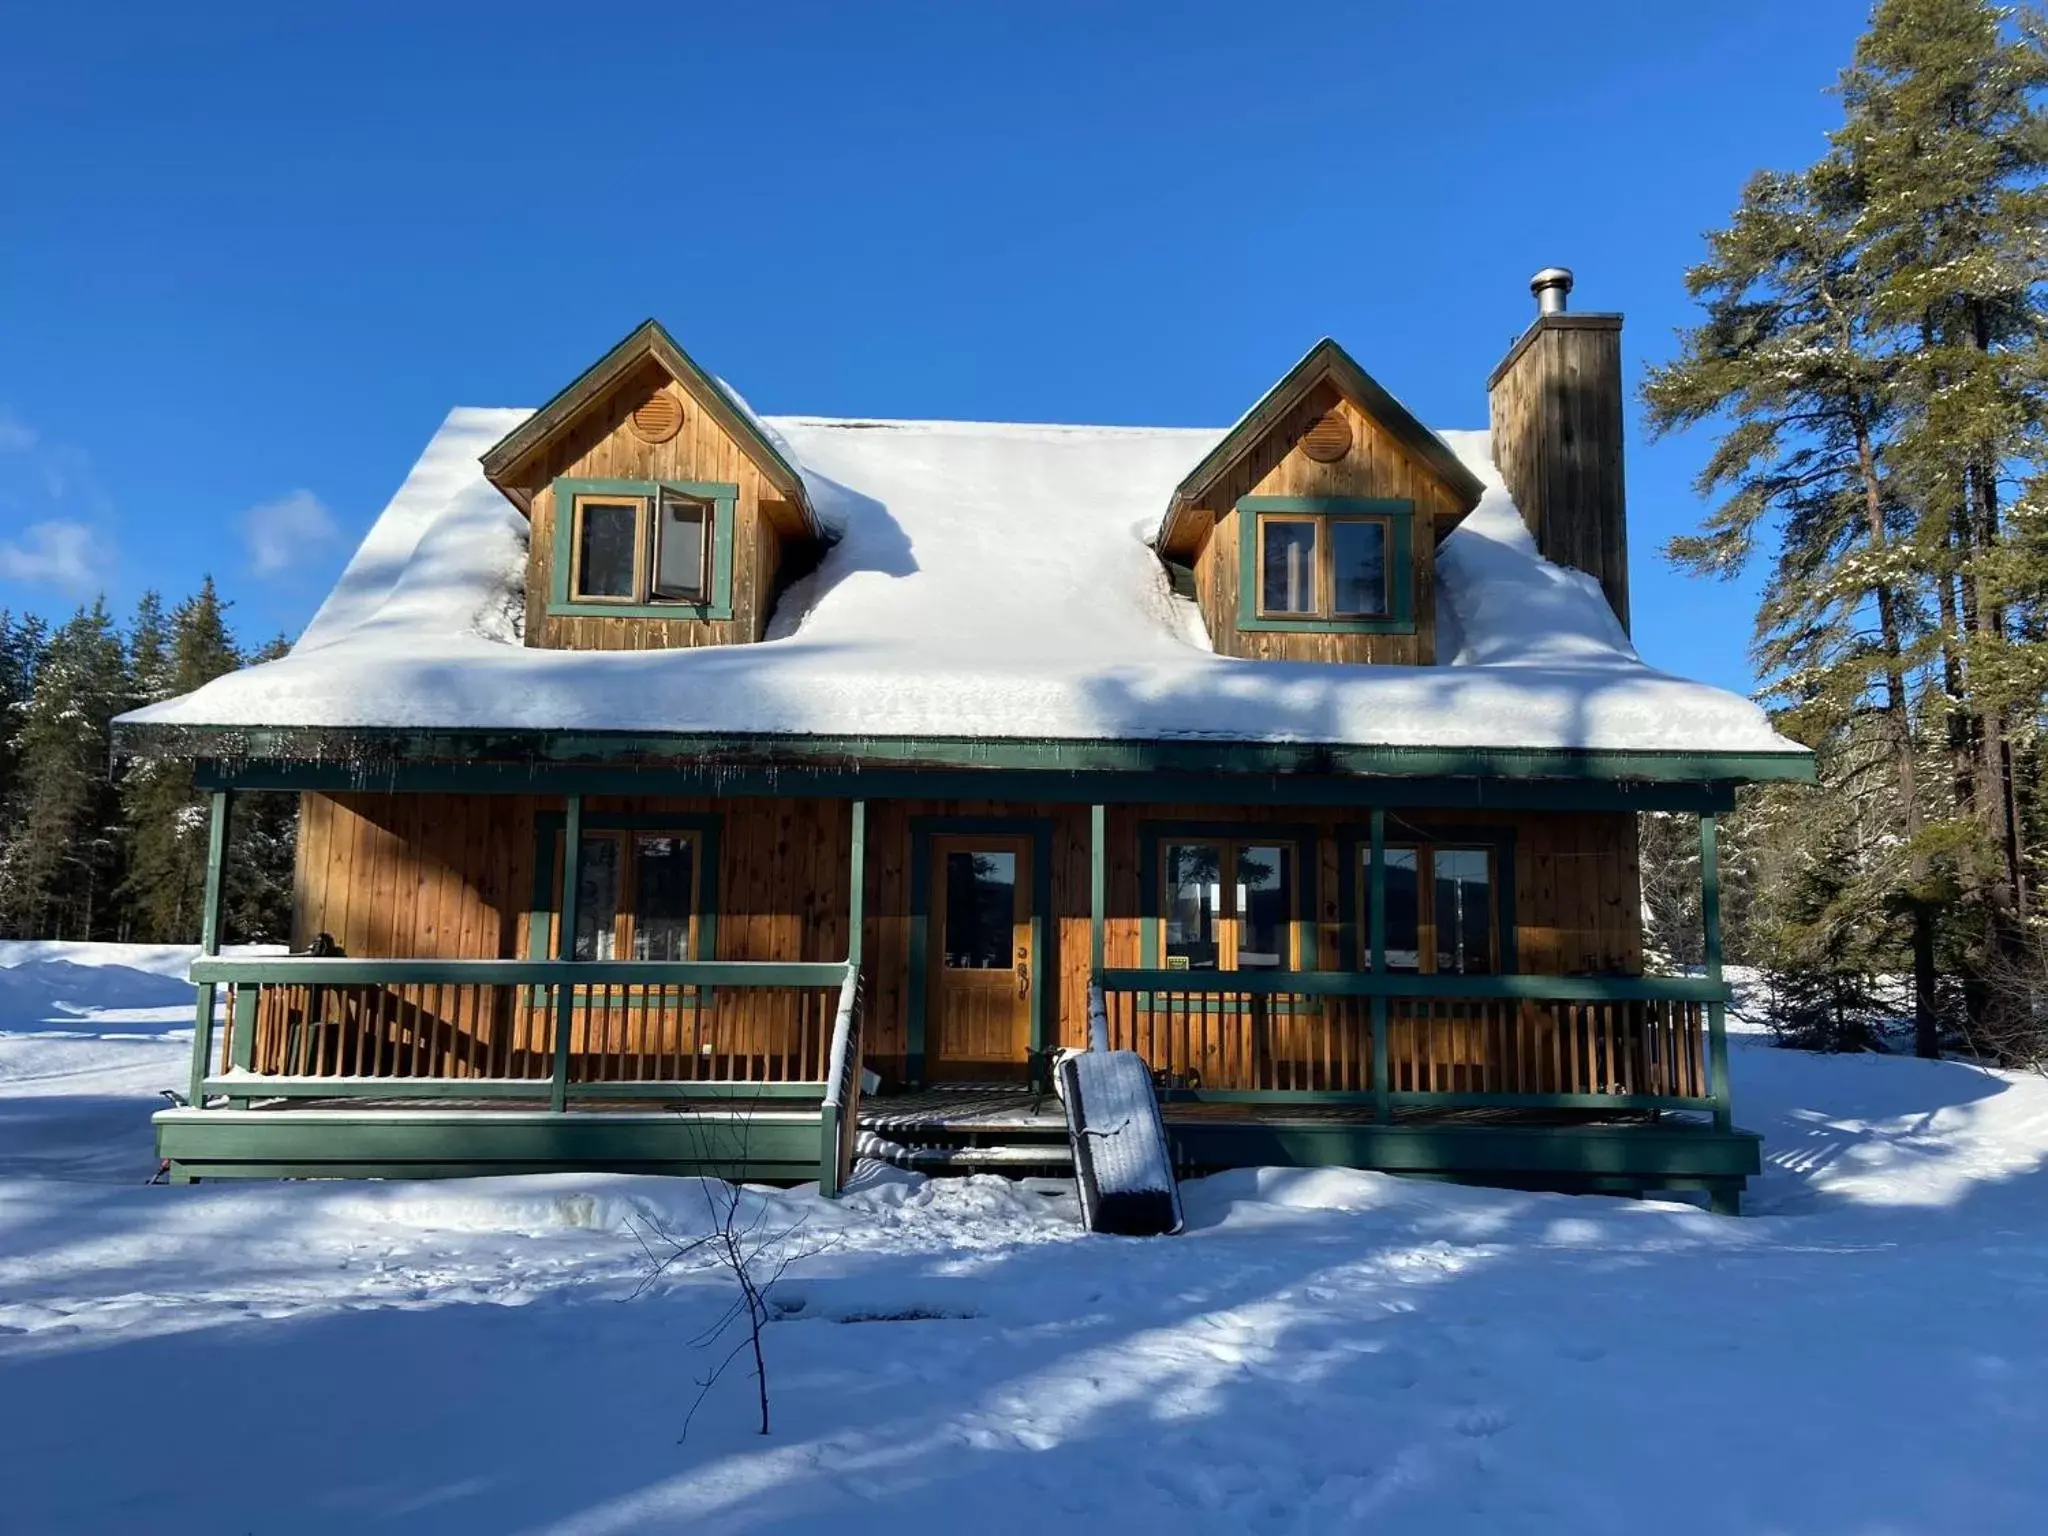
[{"xmin": 526, "ymin": 362, "xmax": 797, "ymax": 651}]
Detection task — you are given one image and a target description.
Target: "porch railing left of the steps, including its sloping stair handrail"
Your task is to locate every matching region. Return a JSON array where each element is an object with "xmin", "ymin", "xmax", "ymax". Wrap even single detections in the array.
[{"xmin": 190, "ymin": 956, "xmax": 860, "ymax": 1192}]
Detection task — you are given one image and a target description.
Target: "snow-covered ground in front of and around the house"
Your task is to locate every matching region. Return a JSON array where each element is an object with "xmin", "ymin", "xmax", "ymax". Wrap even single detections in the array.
[{"xmin": 0, "ymin": 944, "xmax": 2048, "ymax": 1536}]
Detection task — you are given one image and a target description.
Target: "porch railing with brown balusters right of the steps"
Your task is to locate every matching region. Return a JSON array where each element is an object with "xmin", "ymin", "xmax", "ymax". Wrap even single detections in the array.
[{"xmin": 1102, "ymin": 971, "xmax": 1726, "ymax": 1120}]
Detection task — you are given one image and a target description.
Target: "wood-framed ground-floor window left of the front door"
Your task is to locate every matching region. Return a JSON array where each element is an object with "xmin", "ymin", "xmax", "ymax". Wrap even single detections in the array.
[{"xmin": 555, "ymin": 827, "xmax": 707, "ymax": 961}]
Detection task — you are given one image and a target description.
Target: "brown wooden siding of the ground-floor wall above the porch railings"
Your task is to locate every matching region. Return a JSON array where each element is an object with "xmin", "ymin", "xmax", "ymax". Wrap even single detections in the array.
[{"xmin": 295, "ymin": 795, "xmax": 1642, "ymax": 1071}]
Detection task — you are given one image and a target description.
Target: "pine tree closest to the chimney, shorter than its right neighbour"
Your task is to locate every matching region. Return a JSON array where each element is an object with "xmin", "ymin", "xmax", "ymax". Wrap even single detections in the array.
[{"xmin": 1642, "ymin": 160, "xmax": 1937, "ymax": 1055}]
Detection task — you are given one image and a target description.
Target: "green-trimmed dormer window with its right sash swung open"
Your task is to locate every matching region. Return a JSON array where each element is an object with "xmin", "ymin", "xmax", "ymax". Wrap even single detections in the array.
[{"xmin": 549, "ymin": 479, "xmax": 739, "ymax": 618}]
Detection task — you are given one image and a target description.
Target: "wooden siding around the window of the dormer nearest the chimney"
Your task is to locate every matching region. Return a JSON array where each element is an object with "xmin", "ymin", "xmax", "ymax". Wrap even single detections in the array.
[{"xmin": 1194, "ymin": 383, "xmax": 1460, "ymax": 666}]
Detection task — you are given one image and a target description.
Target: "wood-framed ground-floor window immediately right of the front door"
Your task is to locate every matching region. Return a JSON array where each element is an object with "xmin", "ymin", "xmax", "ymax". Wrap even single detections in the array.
[{"xmin": 1157, "ymin": 836, "xmax": 1296, "ymax": 971}]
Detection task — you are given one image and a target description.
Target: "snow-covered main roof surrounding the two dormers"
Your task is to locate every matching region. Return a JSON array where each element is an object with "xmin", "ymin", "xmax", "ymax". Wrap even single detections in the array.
[{"xmin": 123, "ymin": 410, "xmax": 1802, "ymax": 770}]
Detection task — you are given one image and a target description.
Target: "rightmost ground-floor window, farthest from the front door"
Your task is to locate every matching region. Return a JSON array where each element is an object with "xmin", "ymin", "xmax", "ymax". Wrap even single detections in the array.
[{"xmin": 1358, "ymin": 842, "xmax": 1503, "ymax": 975}]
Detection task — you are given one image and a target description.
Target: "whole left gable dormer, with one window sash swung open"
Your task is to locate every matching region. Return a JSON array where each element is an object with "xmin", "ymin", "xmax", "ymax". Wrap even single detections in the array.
[{"xmin": 483, "ymin": 319, "xmax": 819, "ymax": 651}]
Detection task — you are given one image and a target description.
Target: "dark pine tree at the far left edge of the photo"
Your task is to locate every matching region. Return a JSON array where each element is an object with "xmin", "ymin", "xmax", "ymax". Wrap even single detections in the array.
[{"xmin": 0, "ymin": 602, "xmax": 127, "ymax": 938}]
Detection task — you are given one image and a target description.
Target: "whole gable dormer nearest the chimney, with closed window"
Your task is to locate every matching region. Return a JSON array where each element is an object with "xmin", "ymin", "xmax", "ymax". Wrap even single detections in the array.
[{"xmin": 1157, "ymin": 340, "xmax": 1483, "ymax": 666}]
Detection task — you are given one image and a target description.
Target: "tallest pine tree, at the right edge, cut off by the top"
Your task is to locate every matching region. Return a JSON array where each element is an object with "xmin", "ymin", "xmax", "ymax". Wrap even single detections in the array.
[{"xmin": 1833, "ymin": 0, "xmax": 2048, "ymax": 966}]
